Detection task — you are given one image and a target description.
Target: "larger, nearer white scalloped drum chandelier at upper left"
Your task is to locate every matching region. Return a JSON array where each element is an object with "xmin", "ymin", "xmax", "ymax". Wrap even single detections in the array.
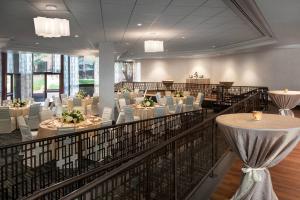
[{"xmin": 33, "ymin": 17, "xmax": 70, "ymax": 38}]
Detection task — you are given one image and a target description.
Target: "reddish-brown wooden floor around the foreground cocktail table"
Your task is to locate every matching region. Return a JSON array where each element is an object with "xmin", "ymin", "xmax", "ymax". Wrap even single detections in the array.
[{"xmin": 211, "ymin": 111, "xmax": 300, "ymax": 200}]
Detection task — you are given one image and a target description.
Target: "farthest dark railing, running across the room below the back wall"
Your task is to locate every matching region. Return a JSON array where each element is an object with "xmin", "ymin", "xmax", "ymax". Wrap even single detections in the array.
[{"xmin": 115, "ymin": 82, "xmax": 268, "ymax": 105}]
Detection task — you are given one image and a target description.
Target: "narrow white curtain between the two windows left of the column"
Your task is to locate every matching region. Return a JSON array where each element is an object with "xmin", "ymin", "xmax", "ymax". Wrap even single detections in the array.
[{"xmin": 70, "ymin": 56, "xmax": 79, "ymax": 96}]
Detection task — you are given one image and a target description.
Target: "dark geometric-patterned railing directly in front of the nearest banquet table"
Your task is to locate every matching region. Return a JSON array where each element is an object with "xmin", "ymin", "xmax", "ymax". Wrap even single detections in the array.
[{"xmin": 0, "ymin": 110, "xmax": 204, "ymax": 200}]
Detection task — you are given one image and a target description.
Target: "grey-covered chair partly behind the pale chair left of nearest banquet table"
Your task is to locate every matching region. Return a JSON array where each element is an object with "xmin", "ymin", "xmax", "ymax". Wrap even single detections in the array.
[{"xmin": 25, "ymin": 103, "xmax": 41, "ymax": 130}]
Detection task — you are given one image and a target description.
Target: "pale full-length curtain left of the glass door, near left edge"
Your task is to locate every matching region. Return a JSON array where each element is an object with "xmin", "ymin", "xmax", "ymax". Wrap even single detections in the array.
[{"xmin": 19, "ymin": 52, "xmax": 32, "ymax": 99}]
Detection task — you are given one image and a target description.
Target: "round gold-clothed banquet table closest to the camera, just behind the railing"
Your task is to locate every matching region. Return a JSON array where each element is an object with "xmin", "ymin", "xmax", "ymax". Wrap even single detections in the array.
[{"xmin": 37, "ymin": 117, "xmax": 101, "ymax": 139}]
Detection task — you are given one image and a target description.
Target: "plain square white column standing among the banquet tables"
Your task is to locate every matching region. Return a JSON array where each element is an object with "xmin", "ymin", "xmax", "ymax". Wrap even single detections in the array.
[{"xmin": 99, "ymin": 42, "xmax": 115, "ymax": 119}]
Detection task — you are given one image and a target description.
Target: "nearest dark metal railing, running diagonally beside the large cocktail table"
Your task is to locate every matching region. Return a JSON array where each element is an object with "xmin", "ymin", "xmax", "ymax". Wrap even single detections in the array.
[{"xmin": 28, "ymin": 91, "xmax": 264, "ymax": 200}]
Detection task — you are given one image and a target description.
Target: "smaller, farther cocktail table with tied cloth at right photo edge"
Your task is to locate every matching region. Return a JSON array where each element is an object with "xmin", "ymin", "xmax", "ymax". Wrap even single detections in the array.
[{"xmin": 268, "ymin": 90, "xmax": 300, "ymax": 117}]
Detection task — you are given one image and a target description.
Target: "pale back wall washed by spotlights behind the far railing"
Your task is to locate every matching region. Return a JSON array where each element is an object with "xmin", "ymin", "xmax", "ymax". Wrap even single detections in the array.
[{"xmin": 140, "ymin": 48, "xmax": 300, "ymax": 90}]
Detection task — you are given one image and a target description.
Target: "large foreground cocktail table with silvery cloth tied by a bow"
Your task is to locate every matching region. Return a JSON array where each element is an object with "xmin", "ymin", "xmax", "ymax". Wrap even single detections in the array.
[{"xmin": 216, "ymin": 113, "xmax": 300, "ymax": 200}]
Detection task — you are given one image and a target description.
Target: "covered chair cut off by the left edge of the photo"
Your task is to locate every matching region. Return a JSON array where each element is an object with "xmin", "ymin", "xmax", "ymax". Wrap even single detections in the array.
[{"xmin": 0, "ymin": 107, "xmax": 16, "ymax": 133}]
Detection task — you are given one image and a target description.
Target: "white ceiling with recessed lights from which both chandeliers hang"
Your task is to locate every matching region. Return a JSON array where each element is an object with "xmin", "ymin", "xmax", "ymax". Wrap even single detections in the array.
[{"xmin": 0, "ymin": 0, "xmax": 274, "ymax": 57}]
